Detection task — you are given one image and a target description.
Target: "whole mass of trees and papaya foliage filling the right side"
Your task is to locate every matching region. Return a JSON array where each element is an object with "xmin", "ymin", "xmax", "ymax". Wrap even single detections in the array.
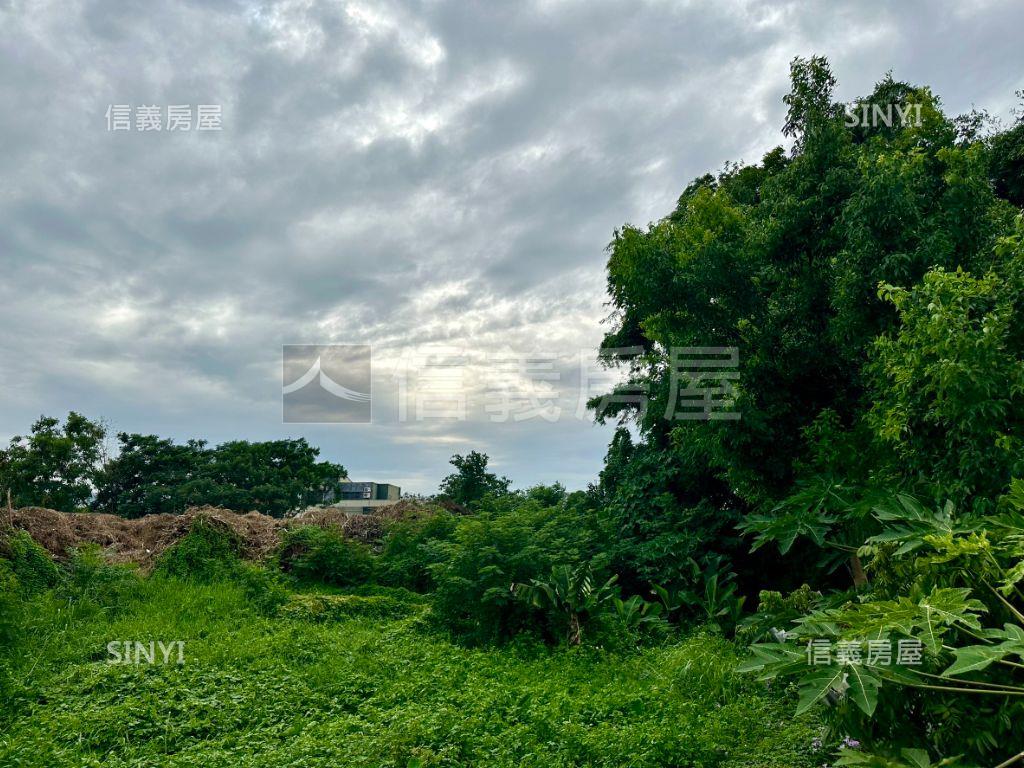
[{"xmin": 592, "ymin": 58, "xmax": 1024, "ymax": 766}]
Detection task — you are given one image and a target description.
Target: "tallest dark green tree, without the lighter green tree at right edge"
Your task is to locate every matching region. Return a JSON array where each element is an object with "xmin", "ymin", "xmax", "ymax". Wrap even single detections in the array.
[{"xmin": 592, "ymin": 57, "xmax": 1017, "ymax": 589}]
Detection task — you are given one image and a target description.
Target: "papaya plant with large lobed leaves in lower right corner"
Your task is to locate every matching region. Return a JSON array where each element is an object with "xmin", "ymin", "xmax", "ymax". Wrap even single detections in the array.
[{"xmin": 740, "ymin": 489, "xmax": 1024, "ymax": 766}]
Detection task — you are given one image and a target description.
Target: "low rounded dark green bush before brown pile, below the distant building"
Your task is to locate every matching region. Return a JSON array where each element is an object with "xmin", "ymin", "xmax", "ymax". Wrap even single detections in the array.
[{"xmin": 278, "ymin": 525, "xmax": 374, "ymax": 587}]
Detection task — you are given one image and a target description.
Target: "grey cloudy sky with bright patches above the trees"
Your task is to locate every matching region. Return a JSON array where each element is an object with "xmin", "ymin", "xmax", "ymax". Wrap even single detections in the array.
[{"xmin": 0, "ymin": 0, "xmax": 1024, "ymax": 492}]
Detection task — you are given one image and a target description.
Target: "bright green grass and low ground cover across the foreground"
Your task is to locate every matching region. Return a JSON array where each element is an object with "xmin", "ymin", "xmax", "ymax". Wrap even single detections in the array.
[{"xmin": 0, "ymin": 578, "xmax": 820, "ymax": 768}]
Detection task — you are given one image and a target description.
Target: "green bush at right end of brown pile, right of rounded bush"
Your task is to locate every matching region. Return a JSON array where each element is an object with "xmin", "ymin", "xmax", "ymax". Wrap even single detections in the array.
[{"xmin": 377, "ymin": 512, "xmax": 456, "ymax": 592}]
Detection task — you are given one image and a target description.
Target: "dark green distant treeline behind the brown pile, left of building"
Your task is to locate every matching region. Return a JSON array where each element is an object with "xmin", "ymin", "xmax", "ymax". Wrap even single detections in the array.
[{"xmin": 0, "ymin": 412, "xmax": 345, "ymax": 517}]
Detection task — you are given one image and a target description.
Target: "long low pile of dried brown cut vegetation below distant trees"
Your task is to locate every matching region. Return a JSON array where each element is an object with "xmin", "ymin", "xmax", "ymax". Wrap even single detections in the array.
[{"xmin": 3, "ymin": 501, "xmax": 437, "ymax": 570}]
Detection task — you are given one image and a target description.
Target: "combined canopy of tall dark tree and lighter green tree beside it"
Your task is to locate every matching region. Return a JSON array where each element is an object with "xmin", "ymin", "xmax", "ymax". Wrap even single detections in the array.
[{"xmin": 591, "ymin": 57, "xmax": 1022, "ymax": 589}]
